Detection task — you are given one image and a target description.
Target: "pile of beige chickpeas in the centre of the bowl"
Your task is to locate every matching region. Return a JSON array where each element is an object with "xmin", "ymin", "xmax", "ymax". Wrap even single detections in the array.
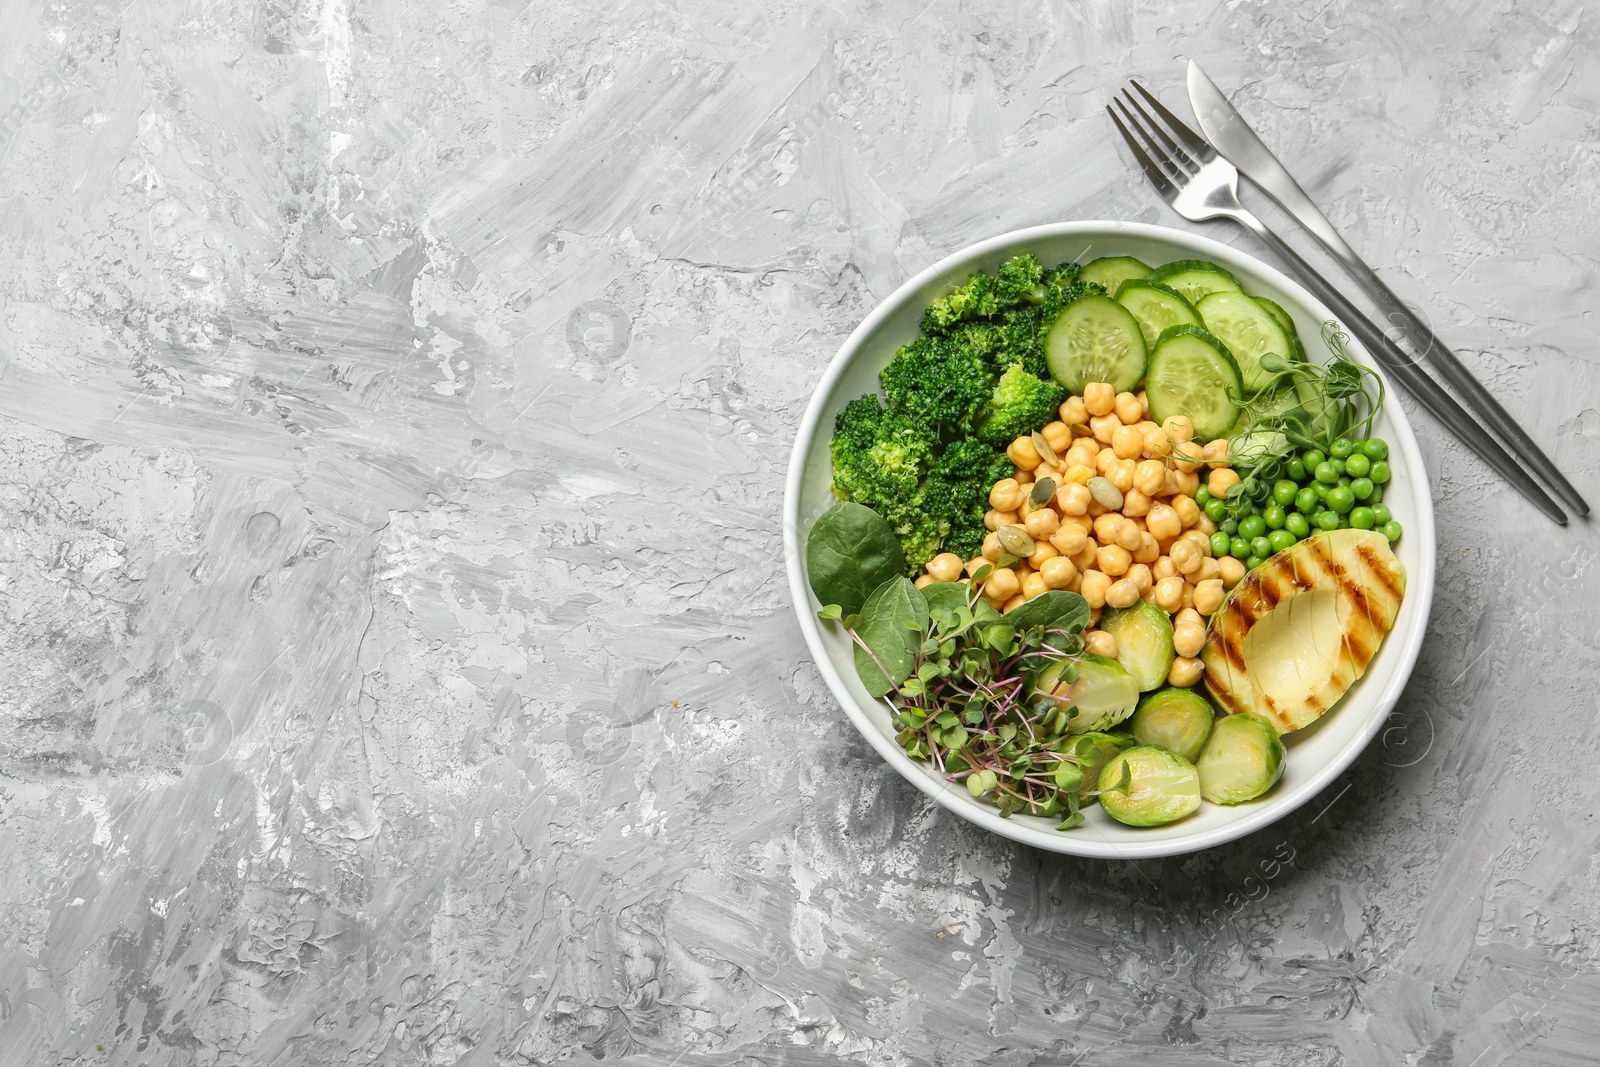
[{"xmin": 917, "ymin": 382, "xmax": 1245, "ymax": 686}]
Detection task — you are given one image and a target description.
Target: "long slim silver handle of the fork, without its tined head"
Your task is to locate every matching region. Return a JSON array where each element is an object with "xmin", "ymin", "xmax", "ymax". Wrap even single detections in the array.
[{"xmin": 1229, "ymin": 211, "xmax": 1566, "ymax": 526}]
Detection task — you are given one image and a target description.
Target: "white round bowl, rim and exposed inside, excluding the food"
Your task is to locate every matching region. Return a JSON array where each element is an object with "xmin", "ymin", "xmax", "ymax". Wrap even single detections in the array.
[{"xmin": 784, "ymin": 222, "xmax": 1435, "ymax": 859}]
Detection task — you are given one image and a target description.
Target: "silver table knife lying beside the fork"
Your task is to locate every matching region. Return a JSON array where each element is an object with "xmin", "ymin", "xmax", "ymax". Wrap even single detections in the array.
[{"xmin": 1189, "ymin": 59, "xmax": 1589, "ymax": 515}]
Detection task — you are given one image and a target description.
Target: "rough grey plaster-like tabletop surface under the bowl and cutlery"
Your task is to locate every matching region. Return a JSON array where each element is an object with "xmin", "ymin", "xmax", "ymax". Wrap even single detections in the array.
[{"xmin": 0, "ymin": 0, "xmax": 1600, "ymax": 1067}]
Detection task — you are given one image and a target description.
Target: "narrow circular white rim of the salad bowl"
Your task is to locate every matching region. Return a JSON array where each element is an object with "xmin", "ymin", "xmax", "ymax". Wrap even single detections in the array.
[{"xmin": 782, "ymin": 221, "xmax": 1437, "ymax": 859}]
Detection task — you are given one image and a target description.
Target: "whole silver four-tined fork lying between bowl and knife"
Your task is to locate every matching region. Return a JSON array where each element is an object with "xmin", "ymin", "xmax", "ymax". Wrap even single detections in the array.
[{"xmin": 1106, "ymin": 82, "xmax": 1566, "ymax": 526}]
